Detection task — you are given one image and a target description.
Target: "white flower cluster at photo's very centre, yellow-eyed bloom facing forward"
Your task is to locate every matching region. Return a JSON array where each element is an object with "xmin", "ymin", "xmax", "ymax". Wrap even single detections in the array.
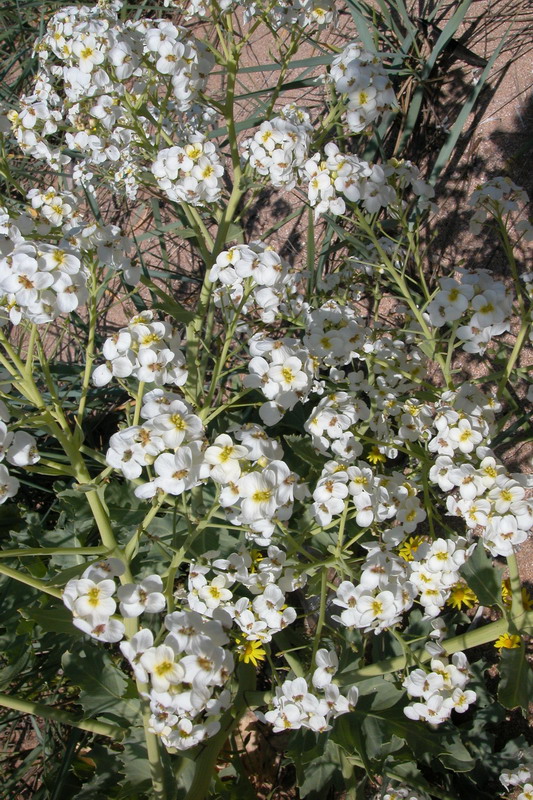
[{"xmin": 243, "ymin": 333, "xmax": 315, "ymax": 425}]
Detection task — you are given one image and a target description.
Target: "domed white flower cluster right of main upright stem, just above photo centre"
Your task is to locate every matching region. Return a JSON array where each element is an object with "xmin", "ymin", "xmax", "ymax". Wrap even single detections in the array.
[{"xmin": 209, "ymin": 242, "xmax": 295, "ymax": 322}]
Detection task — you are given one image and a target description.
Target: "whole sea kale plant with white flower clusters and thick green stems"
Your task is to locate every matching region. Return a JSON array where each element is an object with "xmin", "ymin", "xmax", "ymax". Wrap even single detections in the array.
[{"xmin": 0, "ymin": 0, "xmax": 533, "ymax": 800}]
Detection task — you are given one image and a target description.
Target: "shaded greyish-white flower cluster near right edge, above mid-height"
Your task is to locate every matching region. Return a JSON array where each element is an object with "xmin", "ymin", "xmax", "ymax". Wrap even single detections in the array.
[{"xmin": 426, "ymin": 269, "xmax": 513, "ymax": 355}]
